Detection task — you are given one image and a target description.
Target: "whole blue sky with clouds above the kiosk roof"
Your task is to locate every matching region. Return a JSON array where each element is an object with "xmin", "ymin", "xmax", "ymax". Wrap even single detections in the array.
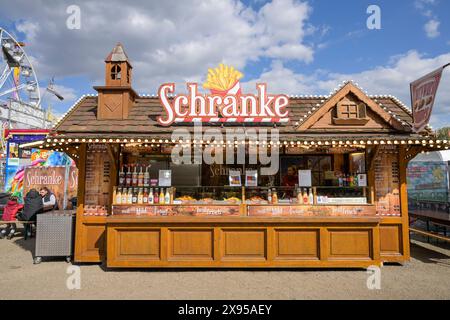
[{"xmin": 0, "ymin": 0, "xmax": 450, "ymax": 128}]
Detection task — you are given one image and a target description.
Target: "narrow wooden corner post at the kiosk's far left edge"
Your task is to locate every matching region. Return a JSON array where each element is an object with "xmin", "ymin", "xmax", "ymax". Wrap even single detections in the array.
[{"xmin": 75, "ymin": 143, "xmax": 87, "ymax": 261}]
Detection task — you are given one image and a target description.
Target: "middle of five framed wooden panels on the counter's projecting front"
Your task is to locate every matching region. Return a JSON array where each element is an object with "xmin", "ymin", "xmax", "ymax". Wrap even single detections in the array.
[{"xmin": 221, "ymin": 229, "xmax": 267, "ymax": 260}]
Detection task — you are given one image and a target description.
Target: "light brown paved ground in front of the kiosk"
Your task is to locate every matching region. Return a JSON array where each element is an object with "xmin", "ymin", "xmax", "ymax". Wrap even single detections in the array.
[{"xmin": 0, "ymin": 232, "xmax": 450, "ymax": 299}]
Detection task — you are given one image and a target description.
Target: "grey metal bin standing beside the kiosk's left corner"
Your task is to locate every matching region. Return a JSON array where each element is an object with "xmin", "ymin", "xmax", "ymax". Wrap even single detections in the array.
[{"xmin": 34, "ymin": 210, "xmax": 75, "ymax": 264}]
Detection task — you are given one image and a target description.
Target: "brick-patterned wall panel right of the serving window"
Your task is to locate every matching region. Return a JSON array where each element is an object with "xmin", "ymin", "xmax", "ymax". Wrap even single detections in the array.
[{"xmin": 374, "ymin": 145, "xmax": 401, "ymax": 216}]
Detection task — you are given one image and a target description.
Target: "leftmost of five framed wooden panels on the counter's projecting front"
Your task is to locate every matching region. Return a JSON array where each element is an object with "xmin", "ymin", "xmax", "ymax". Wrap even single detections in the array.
[{"xmin": 117, "ymin": 229, "xmax": 161, "ymax": 259}]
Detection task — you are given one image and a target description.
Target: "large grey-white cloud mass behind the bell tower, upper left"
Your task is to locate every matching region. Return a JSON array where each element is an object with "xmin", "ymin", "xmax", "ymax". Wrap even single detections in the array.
[{"xmin": 0, "ymin": 0, "xmax": 320, "ymax": 92}]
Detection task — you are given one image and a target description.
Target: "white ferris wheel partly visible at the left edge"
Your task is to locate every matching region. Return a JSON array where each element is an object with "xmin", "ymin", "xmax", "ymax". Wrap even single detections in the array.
[{"xmin": 0, "ymin": 28, "xmax": 45, "ymax": 128}]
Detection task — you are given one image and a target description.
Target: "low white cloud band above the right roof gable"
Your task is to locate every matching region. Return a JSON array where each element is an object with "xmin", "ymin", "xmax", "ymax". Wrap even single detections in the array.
[{"xmin": 243, "ymin": 51, "xmax": 450, "ymax": 128}]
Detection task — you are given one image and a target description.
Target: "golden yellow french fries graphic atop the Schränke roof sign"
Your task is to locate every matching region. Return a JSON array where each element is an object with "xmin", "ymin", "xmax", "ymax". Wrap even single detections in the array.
[{"xmin": 203, "ymin": 63, "xmax": 243, "ymax": 91}]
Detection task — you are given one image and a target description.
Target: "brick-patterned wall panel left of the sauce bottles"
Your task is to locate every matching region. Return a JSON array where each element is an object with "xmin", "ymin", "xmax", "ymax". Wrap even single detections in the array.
[{"xmin": 85, "ymin": 144, "xmax": 111, "ymax": 207}]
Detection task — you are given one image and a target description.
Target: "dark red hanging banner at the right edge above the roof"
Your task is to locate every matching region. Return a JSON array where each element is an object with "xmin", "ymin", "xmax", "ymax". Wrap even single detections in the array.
[{"xmin": 410, "ymin": 66, "xmax": 445, "ymax": 132}]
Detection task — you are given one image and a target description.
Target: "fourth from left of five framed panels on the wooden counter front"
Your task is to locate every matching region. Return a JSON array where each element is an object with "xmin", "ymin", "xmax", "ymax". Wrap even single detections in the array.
[{"xmin": 275, "ymin": 229, "xmax": 320, "ymax": 259}]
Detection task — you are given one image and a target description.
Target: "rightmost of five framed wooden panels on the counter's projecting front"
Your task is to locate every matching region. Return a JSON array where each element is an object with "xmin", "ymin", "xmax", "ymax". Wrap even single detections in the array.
[{"xmin": 329, "ymin": 229, "xmax": 372, "ymax": 259}]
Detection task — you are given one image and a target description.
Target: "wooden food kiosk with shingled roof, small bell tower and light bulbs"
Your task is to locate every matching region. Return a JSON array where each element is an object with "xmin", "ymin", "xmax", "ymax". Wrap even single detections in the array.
[{"xmin": 47, "ymin": 44, "xmax": 448, "ymax": 268}]
